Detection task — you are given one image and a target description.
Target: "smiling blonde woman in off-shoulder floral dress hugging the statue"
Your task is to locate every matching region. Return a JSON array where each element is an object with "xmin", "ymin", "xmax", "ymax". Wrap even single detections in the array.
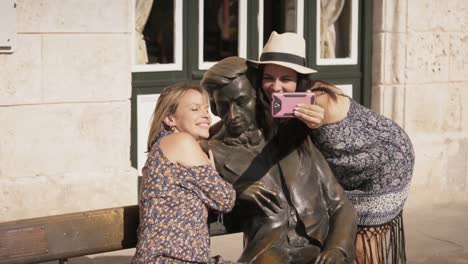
[{"xmin": 132, "ymin": 84, "xmax": 236, "ymax": 263}]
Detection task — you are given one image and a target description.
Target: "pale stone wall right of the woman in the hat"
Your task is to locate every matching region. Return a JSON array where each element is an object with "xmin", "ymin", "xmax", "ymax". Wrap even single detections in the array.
[{"xmin": 372, "ymin": 0, "xmax": 468, "ymax": 205}]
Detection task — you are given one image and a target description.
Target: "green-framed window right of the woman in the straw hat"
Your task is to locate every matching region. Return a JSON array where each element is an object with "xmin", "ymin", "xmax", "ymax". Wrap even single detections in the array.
[{"xmin": 304, "ymin": 0, "xmax": 373, "ymax": 106}]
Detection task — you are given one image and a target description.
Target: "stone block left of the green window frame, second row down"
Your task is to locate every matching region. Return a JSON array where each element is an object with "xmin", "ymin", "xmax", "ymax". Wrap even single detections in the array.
[{"xmin": 43, "ymin": 34, "xmax": 131, "ymax": 102}]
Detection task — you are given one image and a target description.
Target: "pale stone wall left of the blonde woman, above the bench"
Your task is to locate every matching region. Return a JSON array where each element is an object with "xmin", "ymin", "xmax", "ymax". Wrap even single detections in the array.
[{"xmin": 0, "ymin": 0, "xmax": 137, "ymax": 221}]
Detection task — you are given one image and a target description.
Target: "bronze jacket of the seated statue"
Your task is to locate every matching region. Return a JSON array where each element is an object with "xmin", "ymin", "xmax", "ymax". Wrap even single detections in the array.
[{"xmin": 208, "ymin": 131, "xmax": 356, "ymax": 263}]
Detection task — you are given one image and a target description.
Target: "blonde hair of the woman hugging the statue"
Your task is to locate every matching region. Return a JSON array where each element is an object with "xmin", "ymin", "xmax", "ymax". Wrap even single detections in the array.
[{"xmin": 146, "ymin": 83, "xmax": 209, "ymax": 152}]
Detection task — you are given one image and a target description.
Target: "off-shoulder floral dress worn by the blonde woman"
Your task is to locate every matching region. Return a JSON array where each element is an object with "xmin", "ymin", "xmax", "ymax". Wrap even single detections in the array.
[{"xmin": 132, "ymin": 131, "xmax": 236, "ymax": 263}]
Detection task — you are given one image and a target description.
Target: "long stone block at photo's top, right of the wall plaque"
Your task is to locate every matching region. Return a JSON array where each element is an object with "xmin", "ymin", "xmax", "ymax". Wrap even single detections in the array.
[{"xmin": 17, "ymin": 0, "xmax": 133, "ymax": 33}]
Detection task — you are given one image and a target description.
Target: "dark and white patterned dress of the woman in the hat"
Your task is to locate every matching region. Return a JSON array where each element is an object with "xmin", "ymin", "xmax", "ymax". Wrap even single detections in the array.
[{"xmin": 311, "ymin": 99, "xmax": 414, "ymax": 226}]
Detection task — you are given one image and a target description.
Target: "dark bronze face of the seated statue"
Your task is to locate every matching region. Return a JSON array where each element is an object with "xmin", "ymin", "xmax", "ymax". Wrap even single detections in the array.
[{"xmin": 213, "ymin": 76, "xmax": 255, "ymax": 137}]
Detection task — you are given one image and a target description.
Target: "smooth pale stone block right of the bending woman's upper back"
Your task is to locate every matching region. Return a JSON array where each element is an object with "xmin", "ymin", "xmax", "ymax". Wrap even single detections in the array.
[{"xmin": 405, "ymin": 84, "xmax": 466, "ymax": 133}]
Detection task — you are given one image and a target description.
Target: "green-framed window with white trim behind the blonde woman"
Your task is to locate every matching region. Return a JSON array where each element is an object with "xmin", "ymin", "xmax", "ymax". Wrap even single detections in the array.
[{"xmin": 131, "ymin": 0, "xmax": 247, "ymax": 171}]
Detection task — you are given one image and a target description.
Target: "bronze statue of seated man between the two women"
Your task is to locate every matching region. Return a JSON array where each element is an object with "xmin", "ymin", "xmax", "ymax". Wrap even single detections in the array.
[{"xmin": 201, "ymin": 57, "xmax": 356, "ymax": 263}]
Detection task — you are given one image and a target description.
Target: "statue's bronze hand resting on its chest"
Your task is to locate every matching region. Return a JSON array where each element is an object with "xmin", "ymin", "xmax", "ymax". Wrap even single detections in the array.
[{"xmin": 239, "ymin": 182, "xmax": 281, "ymax": 217}]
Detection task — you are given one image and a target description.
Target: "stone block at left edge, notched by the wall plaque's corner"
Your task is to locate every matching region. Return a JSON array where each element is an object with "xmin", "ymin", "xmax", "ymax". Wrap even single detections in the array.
[{"xmin": 0, "ymin": 34, "xmax": 42, "ymax": 105}]
